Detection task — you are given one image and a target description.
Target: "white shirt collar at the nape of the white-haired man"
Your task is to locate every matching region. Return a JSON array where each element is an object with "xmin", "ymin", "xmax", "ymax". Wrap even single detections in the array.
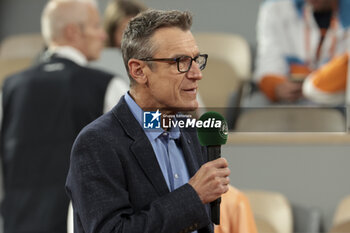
[{"xmin": 49, "ymin": 46, "xmax": 88, "ymax": 66}]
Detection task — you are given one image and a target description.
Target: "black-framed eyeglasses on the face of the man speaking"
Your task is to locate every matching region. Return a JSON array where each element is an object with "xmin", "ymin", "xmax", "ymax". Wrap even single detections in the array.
[{"xmin": 139, "ymin": 54, "xmax": 208, "ymax": 73}]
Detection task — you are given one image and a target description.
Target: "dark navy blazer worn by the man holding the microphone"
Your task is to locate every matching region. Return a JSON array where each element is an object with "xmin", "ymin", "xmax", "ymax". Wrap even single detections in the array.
[{"xmin": 66, "ymin": 98, "xmax": 213, "ymax": 233}]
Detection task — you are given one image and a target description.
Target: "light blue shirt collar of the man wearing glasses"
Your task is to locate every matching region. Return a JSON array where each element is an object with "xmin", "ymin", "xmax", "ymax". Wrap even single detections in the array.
[{"xmin": 124, "ymin": 92, "xmax": 180, "ymax": 140}]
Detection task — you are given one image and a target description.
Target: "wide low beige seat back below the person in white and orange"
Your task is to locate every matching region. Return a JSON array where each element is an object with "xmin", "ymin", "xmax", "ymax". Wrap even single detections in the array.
[{"xmin": 235, "ymin": 107, "xmax": 346, "ymax": 132}]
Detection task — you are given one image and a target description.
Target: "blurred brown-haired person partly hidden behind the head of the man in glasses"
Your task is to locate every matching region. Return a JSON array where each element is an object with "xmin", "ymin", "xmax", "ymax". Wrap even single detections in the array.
[{"xmin": 91, "ymin": 0, "xmax": 147, "ymax": 83}]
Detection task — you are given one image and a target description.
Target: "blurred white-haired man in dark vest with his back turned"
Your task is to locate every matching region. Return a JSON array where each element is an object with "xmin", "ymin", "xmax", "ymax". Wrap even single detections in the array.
[{"xmin": 1, "ymin": 0, "xmax": 126, "ymax": 233}]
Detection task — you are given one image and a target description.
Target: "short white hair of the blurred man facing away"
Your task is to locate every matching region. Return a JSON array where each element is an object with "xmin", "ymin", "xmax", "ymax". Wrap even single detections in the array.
[{"xmin": 41, "ymin": 0, "xmax": 97, "ymax": 45}]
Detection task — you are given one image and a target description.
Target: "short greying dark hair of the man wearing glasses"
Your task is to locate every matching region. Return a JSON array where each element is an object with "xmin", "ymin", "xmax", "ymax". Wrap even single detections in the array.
[{"xmin": 121, "ymin": 10, "xmax": 192, "ymax": 85}]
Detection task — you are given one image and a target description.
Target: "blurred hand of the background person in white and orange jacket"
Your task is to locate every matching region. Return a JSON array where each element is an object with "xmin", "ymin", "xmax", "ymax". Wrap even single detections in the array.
[{"xmin": 275, "ymin": 81, "xmax": 303, "ymax": 102}]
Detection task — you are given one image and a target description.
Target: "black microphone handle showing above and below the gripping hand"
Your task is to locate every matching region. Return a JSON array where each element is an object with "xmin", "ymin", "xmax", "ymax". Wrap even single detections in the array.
[{"xmin": 207, "ymin": 145, "xmax": 221, "ymax": 225}]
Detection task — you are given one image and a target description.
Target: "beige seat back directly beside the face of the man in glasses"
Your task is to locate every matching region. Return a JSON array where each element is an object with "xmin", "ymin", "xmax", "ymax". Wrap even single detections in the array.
[{"xmin": 194, "ymin": 33, "xmax": 251, "ymax": 108}]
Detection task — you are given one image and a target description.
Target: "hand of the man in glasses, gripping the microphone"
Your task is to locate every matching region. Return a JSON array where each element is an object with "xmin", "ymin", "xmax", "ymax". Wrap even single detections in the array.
[{"xmin": 188, "ymin": 158, "xmax": 230, "ymax": 204}]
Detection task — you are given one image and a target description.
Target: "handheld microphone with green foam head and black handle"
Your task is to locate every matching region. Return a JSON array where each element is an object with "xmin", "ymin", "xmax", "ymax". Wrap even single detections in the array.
[{"xmin": 197, "ymin": 111, "xmax": 228, "ymax": 225}]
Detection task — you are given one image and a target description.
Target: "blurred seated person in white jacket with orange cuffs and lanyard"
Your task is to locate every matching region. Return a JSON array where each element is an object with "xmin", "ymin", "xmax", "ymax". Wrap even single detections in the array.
[{"xmin": 251, "ymin": 0, "xmax": 347, "ymax": 106}]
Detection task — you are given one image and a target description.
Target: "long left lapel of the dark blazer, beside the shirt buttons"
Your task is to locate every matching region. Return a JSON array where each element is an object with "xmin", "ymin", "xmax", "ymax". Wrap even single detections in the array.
[{"xmin": 112, "ymin": 97, "xmax": 169, "ymax": 196}]
